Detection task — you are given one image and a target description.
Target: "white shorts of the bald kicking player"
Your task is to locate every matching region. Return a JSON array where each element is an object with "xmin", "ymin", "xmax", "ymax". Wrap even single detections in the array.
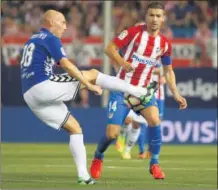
[{"xmin": 23, "ymin": 75, "xmax": 80, "ymax": 129}]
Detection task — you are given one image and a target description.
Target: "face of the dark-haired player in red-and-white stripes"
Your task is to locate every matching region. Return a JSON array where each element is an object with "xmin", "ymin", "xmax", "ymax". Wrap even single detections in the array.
[{"xmin": 145, "ymin": 9, "xmax": 165, "ymax": 32}]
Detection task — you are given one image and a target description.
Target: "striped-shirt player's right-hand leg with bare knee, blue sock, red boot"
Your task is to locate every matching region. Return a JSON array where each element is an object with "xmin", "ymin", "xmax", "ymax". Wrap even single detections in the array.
[{"xmin": 142, "ymin": 106, "xmax": 165, "ymax": 179}]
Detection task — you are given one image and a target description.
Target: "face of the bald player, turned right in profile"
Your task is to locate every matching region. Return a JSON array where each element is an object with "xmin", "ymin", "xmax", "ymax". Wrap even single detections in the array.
[{"xmin": 53, "ymin": 15, "xmax": 67, "ymax": 38}]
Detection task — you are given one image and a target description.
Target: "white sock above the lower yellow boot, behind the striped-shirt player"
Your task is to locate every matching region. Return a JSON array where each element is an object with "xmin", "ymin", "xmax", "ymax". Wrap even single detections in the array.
[{"xmin": 124, "ymin": 127, "xmax": 141, "ymax": 152}]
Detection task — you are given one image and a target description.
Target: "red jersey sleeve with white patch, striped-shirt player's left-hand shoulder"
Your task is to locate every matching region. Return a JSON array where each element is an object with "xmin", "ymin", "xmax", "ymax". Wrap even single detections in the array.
[{"xmin": 112, "ymin": 27, "xmax": 139, "ymax": 49}]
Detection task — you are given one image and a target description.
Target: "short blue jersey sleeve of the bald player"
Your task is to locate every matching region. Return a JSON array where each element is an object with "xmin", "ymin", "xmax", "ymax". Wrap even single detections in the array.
[{"xmin": 45, "ymin": 37, "xmax": 67, "ymax": 62}]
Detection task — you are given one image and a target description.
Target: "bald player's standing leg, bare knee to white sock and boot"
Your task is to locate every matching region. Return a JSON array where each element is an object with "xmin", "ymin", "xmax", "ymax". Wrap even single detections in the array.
[{"xmin": 63, "ymin": 115, "xmax": 95, "ymax": 185}]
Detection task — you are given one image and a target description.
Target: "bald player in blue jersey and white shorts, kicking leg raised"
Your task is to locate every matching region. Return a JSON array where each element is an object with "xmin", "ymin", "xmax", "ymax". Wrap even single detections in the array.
[{"xmin": 20, "ymin": 10, "xmax": 159, "ymax": 185}]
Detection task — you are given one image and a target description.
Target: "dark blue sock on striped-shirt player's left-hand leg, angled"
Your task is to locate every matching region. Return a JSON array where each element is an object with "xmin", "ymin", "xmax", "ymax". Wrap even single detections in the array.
[{"xmin": 94, "ymin": 135, "xmax": 115, "ymax": 160}]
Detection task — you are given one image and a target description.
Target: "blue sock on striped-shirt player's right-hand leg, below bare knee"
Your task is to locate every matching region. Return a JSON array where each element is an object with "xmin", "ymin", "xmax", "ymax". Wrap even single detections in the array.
[{"xmin": 148, "ymin": 125, "xmax": 162, "ymax": 165}]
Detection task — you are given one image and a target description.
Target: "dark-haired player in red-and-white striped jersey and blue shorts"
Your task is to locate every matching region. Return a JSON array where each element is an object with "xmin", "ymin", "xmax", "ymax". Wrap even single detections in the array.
[{"xmin": 90, "ymin": 2, "xmax": 187, "ymax": 179}]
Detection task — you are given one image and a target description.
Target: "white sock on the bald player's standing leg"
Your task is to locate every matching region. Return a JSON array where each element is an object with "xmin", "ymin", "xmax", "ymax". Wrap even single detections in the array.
[{"xmin": 69, "ymin": 134, "xmax": 90, "ymax": 180}]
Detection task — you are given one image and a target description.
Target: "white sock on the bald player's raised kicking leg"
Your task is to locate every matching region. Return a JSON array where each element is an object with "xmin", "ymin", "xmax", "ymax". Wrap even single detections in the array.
[{"xmin": 96, "ymin": 72, "xmax": 147, "ymax": 98}]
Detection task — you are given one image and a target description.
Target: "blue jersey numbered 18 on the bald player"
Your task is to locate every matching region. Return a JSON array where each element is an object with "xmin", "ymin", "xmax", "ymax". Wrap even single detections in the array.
[{"xmin": 21, "ymin": 28, "xmax": 66, "ymax": 94}]
